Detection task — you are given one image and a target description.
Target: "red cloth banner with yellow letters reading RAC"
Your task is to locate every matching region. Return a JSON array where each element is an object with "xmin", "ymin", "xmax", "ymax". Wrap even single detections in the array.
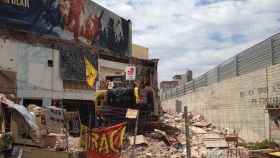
[{"xmin": 87, "ymin": 123, "xmax": 125, "ymax": 158}]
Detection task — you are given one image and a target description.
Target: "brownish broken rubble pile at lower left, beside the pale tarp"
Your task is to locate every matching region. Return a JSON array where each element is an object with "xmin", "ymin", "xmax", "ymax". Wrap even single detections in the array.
[{"xmin": 15, "ymin": 105, "xmax": 84, "ymax": 152}]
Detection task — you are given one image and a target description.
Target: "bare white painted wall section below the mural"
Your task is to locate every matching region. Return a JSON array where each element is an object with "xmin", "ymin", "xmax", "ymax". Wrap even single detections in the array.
[{"xmin": 0, "ymin": 39, "xmax": 95, "ymax": 106}]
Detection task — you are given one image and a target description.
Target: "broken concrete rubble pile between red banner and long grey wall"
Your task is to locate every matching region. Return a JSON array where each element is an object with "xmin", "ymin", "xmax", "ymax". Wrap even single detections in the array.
[{"xmin": 122, "ymin": 113, "xmax": 248, "ymax": 158}]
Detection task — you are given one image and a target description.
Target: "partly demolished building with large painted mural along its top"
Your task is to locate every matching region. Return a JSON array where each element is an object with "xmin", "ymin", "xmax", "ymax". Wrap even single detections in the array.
[{"xmin": 0, "ymin": 0, "xmax": 159, "ymax": 139}]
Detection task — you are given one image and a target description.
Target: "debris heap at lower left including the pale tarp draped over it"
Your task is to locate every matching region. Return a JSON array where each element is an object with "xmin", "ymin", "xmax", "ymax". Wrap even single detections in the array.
[{"xmin": 0, "ymin": 94, "xmax": 84, "ymax": 153}]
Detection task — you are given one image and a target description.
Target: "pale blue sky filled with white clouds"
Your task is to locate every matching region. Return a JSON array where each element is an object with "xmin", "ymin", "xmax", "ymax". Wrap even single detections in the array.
[{"xmin": 94, "ymin": 0, "xmax": 280, "ymax": 80}]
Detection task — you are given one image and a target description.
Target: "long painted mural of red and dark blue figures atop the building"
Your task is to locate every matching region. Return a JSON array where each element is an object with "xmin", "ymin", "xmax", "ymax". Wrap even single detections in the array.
[{"xmin": 0, "ymin": 0, "xmax": 129, "ymax": 56}]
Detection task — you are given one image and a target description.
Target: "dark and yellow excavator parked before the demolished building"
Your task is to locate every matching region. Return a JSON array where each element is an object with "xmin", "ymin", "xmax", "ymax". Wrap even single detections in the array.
[{"xmin": 94, "ymin": 59, "xmax": 161, "ymax": 126}]
